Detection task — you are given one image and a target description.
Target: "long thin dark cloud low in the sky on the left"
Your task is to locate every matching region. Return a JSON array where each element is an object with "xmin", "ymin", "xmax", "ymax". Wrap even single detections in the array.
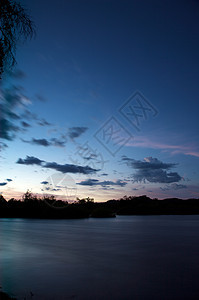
[{"xmin": 16, "ymin": 156, "xmax": 100, "ymax": 174}]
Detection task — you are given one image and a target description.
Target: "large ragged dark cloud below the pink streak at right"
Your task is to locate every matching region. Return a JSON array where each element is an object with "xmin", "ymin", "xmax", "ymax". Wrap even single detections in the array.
[{"xmin": 122, "ymin": 156, "xmax": 182, "ymax": 183}]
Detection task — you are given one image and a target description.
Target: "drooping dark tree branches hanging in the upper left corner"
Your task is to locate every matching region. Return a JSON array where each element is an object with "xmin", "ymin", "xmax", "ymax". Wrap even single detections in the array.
[{"xmin": 0, "ymin": 0, "xmax": 35, "ymax": 78}]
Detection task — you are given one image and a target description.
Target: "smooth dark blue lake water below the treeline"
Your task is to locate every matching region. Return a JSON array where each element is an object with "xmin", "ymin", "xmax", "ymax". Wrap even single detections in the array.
[{"xmin": 0, "ymin": 216, "xmax": 199, "ymax": 300}]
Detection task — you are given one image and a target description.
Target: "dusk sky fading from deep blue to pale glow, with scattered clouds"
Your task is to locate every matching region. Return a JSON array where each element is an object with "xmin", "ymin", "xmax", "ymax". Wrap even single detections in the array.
[{"xmin": 0, "ymin": 0, "xmax": 199, "ymax": 201}]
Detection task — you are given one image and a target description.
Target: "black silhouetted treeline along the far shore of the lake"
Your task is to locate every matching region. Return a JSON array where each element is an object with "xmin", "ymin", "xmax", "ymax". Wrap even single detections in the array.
[{"xmin": 0, "ymin": 191, "xmax": 199, "ymax": 219}]
